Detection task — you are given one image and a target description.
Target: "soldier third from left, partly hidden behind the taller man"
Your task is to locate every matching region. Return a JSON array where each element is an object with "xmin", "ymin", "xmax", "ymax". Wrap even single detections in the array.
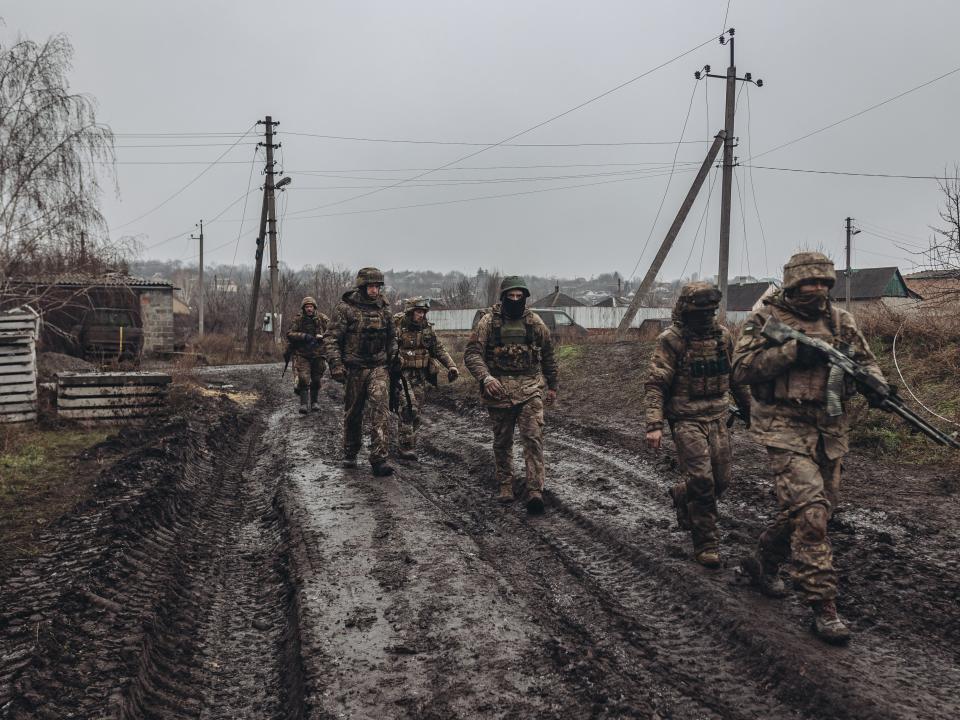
[{"xmin": 393, "ymin": 297, "xmax": 460, "ymax": 460}]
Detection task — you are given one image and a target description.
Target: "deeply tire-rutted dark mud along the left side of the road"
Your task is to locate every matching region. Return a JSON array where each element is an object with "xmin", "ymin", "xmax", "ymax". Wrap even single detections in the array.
[{"xmin": 0, "ymin": 380, "xmax": 303, "ymax": 718}]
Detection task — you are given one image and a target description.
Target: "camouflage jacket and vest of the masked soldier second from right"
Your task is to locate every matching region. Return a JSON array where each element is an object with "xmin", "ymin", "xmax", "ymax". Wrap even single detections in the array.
[{"xmin": 645, "ymin": 321, "xmax": 750, "ymax": 432}]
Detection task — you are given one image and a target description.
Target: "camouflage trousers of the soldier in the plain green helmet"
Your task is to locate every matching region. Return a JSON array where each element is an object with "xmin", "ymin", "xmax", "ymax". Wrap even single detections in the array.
[{"xmin": 487, "ymin": 396, "xmax": 545, "ymax": 492}]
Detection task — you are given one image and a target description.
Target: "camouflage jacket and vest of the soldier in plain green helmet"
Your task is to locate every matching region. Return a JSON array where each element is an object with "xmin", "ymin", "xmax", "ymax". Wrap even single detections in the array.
[{"xmin": 463, "ymin": 304, "xmax": 558, "ymax": 407}]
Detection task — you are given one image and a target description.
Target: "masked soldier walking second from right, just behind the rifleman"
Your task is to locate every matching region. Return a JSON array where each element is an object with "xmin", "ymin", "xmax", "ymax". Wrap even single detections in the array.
[{"xmin": 646, "ymin": 282, "xmax": 750, "ymax": 568}]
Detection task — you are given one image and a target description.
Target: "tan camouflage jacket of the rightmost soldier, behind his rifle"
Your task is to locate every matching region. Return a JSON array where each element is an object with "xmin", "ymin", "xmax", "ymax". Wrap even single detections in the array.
[{"xmin": 733, "ymin": 293, "xmax": 883, "ymax": 460}]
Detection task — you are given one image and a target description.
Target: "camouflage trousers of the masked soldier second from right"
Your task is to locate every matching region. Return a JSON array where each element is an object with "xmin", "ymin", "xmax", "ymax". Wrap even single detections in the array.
[{"xmin": 670, "ymin": 419, "xmax": 730, "ymax": 552}]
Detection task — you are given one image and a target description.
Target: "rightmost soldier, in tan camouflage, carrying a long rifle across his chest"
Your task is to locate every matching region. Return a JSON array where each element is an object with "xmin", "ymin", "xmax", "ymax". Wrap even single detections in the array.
[{"xmin": 733, "ymin": 252, "xmax": 885, "ymax": 643}]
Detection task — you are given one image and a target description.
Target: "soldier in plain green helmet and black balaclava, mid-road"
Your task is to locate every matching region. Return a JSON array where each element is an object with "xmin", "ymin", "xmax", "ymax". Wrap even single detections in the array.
[{"xmin": 463, "ymin": 276, "xmax": 557, "ymax": 514}]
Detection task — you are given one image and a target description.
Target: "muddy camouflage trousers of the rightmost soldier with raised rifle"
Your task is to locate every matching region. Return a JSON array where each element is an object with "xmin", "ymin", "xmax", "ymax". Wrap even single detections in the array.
[{"xmin": 757, "ymin": 443, "xmax": 840, "ymax": 602}]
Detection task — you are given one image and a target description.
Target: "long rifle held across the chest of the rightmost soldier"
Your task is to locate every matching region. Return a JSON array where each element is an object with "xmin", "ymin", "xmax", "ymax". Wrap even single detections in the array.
[{"xmin": 760, "ymin": 317, "xmax": 960, "ymax": 450}]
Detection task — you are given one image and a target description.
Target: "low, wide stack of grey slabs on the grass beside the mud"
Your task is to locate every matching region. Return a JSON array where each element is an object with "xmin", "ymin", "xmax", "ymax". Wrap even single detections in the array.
[{"xmin": 57, "ymin": 372, "xmax": 171, "ymax": 424}]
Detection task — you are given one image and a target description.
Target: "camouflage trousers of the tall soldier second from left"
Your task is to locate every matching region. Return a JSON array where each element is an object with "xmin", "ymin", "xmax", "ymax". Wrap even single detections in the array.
[{"xmin": 343, "ymin": 367, "xmax": 390, "ymax": 465}]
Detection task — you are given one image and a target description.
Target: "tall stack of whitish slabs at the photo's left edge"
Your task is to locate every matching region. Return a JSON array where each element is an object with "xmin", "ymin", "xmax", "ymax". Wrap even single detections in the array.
[{"xmin": 0, "ymin": 308, "xmax": 40, "ymax": 423}]
